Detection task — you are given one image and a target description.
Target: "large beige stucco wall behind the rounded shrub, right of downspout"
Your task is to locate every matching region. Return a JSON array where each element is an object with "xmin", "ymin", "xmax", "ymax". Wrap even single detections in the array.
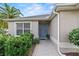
[{"xmin": 59, "ymin": 11, "xmax": 79, "ymax": 42}]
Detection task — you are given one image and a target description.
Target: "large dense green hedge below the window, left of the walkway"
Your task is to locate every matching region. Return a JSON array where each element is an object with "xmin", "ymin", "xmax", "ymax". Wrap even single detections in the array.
[{"xmin": 0, "ymin": 33, "xmax": 33, "ymax": 56}]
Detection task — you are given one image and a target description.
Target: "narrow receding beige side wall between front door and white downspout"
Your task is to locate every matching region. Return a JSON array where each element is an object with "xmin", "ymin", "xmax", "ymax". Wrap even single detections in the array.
[{"xmin": 49, "ymin": 16, "xmax": 58, "ymax": 44}]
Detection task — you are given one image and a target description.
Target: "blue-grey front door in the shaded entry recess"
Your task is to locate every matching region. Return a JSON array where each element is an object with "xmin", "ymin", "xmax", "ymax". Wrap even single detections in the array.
[{"xmin": 39, "ymin": 23, "xmax": 48, "ymax": 39}]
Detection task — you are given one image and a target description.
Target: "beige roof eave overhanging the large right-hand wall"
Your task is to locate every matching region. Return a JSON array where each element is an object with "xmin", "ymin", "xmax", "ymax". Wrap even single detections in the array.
[{"xmin": 55, "ymin": 3, "xmax": 79, "ymax": 12}]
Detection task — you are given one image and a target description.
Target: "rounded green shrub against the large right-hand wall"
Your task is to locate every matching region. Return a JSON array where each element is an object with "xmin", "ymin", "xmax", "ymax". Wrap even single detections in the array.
[{"xmin": 69, "ymin": 28, "xmax": 79, "ymax": 46}]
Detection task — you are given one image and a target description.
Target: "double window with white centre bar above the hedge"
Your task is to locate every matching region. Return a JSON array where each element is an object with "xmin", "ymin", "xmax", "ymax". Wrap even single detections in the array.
[{"xmin": 16, "ymin": 23, "xmax": 30, "ymax": 35}]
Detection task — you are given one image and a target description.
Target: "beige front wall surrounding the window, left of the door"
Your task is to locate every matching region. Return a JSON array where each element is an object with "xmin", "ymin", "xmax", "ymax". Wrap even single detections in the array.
[{"xmin": 8, "ymin": 21, "xmax": 39, "ymax": 37}]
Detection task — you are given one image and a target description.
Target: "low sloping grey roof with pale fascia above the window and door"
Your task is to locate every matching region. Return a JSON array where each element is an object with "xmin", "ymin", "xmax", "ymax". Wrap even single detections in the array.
[{"xmin": 4, "ymin": 14, "xmax": 50, "ymax": 21}]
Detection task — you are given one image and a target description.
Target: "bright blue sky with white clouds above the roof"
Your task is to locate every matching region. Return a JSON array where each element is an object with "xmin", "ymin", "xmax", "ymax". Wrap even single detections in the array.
[{"xmin": 0, "ymin": 3, "xmax": 55, "ymax": 17}]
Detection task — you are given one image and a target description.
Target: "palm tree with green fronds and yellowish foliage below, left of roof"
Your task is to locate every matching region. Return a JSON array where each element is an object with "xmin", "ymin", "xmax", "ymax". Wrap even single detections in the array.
[{"xmin": 0, "ymin": 3, "xmax": 23, "ymax": 28}]
